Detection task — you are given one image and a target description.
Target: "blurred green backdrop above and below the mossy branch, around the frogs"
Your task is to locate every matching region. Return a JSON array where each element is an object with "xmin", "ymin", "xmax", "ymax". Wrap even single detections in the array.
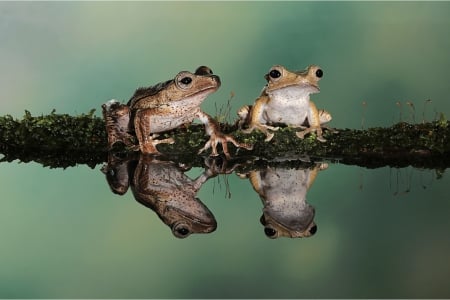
[{"xmin": 0, "ymin": 2, "xmax": 450, "ymax": 298}]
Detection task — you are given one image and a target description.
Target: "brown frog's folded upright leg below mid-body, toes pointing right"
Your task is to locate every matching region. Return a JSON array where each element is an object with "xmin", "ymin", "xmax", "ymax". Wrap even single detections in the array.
[{"xmin": 134, "ymin": 109, "xmax": 174, "ymax": 154}]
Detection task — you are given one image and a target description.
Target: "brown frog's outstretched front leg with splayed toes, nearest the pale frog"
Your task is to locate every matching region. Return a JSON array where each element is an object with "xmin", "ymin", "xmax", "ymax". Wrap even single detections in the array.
[{"xmin": 196, "ymin": 111, "xmax": 253, "ymax": 159}]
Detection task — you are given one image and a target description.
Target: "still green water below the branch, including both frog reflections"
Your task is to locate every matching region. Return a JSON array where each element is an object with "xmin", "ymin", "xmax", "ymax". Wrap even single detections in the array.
[{"xmin": 0, "ymin": 158, "xmax": 450, "ymax": 298}]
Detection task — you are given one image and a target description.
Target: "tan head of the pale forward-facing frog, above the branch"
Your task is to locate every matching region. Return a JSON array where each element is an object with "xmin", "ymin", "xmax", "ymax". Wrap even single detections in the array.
[{"xmin": 264, "ymin": 65, "xmax": 323, "ymax": 94}]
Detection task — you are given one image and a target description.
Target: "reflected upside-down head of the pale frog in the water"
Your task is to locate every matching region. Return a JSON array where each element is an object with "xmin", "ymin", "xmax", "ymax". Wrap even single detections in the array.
[{"xmin": 260, "ymin": 204, "xmax": 317, "ymax": 239}]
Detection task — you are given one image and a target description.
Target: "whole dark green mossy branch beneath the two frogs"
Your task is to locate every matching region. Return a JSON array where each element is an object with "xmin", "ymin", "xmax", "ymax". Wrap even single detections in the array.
[{"xmin": 0, "ymin": 110, "xmax": 450, "ymax": 169}]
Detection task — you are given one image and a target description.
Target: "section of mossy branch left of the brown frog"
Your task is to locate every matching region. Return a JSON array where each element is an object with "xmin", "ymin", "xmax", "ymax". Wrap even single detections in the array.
[{"xmin": 0, "ymin": 110, "xmax": 106, "ymax": 167}]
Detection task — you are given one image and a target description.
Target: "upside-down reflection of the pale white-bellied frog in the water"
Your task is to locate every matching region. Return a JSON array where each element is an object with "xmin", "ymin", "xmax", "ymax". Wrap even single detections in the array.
[{"xmin": 246, "ymin": 163, "xmax": 328, "ymax": 238}]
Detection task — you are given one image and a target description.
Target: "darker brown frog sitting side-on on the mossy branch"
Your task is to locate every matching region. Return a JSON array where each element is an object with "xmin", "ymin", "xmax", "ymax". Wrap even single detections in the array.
[{"xmin": 102, "ymin": 66, "xmax": 252, "ymax": 158}]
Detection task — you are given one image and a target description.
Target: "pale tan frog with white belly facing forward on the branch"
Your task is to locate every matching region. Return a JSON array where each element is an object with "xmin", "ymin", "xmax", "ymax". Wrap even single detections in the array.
[{"xmin": 238, "ymin": 65, "xmax": 332, "ymax": 142}]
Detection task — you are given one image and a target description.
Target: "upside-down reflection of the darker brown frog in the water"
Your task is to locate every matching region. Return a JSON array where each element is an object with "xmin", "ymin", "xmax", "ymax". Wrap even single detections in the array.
[{"xmin": 102, "ymin": 154, "xmax": 221, "ymax": 238}]
